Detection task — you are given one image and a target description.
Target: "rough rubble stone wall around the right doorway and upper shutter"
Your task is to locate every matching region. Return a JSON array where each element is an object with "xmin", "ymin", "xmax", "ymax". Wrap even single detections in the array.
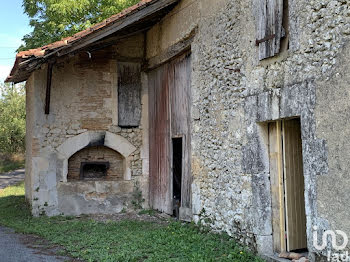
[{"xmin": 147, "ymin": 0, "xmax": 350, "ymax": 254}]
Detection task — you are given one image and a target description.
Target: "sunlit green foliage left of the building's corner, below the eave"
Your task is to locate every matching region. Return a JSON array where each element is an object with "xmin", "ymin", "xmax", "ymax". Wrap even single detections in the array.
[{"xmin": 0, "ymin": 84, "xmax": 26, "ymax": 154}]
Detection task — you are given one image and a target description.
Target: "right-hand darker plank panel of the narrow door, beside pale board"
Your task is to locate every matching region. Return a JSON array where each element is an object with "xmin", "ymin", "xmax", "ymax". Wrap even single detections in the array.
[{"xmin": 283, "ymin": 119, "xmax": 307, "ymax": 251}]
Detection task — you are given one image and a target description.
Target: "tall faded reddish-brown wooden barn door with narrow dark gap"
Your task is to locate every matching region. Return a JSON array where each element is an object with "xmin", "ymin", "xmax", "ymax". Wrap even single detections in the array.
[{"xmin": 149, "ymin": 54, "xmax": 192, "ymax": 217}]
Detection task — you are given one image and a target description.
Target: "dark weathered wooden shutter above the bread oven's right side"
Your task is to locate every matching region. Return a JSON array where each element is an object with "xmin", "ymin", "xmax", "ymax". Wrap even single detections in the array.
[{"xmin": 118, "ymin": 62, "xmax": 141, "ymax": 127}]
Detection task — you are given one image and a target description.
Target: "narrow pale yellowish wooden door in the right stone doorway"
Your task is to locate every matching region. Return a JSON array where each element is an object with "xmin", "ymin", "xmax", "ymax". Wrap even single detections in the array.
[{"xmin": 268, "ymin": 119, "xmax": 307, "ymax": 252}]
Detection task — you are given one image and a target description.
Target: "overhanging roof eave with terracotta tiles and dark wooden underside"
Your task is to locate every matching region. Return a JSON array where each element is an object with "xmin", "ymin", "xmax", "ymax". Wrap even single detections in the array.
[{"xmin": 5, "ymin": 0, "xmax": 180, "ymax": 83}]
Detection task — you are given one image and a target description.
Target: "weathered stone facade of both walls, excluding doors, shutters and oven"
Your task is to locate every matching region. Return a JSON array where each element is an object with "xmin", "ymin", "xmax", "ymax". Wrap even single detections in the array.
[{"xmin": 22, "ymin": 0, "xmax": 350, "ymax": 259}]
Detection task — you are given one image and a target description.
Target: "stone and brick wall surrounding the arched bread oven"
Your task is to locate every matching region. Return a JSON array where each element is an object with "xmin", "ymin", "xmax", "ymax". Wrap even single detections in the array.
[{"xmin": 27, "ymin": 32, "xmax": 148, "ymax": 215}]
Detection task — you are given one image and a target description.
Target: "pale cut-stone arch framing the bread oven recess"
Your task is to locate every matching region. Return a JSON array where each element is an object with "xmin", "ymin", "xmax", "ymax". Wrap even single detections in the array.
[{"xmin": 57, "ymin": 131, "xmax": 136, "ymax": 182}]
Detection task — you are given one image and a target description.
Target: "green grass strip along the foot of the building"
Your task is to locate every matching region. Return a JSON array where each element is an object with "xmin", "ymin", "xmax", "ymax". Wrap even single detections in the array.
[{"xmin": 0, "ymin": 184, "xmax": 263, "ymax": 262}]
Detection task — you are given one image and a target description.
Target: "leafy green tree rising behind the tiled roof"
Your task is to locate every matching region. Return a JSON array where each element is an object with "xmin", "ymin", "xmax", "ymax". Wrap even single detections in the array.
[{"xmin": 19, "ymin": 0, "xmax": 139, "ymax": 51}]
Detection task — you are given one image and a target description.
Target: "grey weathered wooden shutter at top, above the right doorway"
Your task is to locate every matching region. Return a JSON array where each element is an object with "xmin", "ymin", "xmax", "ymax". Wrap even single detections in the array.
[{"xmin": 254, "ymin": 0, "xmax": 283, "ymax": 60}]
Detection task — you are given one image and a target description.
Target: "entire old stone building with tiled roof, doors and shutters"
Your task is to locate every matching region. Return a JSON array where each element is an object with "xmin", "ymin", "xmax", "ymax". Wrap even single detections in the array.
[{"xmin": 7, "ymin": 0, "xmax": 350, "ymax": 261}]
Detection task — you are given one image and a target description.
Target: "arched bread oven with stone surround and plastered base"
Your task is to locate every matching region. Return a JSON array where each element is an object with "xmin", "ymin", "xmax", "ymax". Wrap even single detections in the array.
[{"xmin": 57, "ymin": 131, "xmax": 136, "ymax": 215}]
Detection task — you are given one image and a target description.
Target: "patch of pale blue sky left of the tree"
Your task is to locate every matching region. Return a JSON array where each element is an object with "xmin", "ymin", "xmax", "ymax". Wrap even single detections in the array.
[{"xmin": 0, "ymin": 0, "xmax": 32, "ymax": 81}]
